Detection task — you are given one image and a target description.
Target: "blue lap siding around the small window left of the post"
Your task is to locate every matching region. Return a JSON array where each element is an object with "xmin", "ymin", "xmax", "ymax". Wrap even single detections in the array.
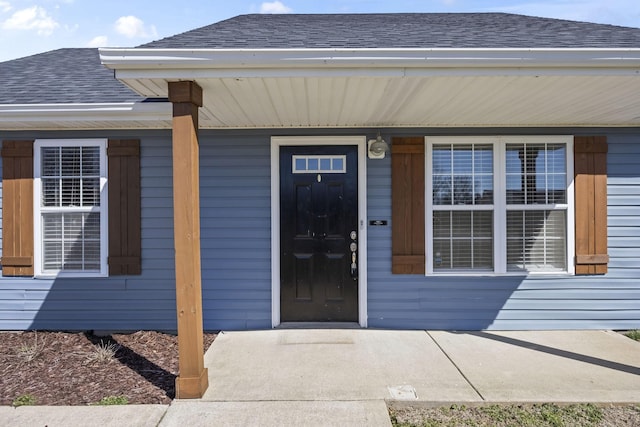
[{"xmin": 0, "ymin": 132, "xmax": 176, "ymax": 331}]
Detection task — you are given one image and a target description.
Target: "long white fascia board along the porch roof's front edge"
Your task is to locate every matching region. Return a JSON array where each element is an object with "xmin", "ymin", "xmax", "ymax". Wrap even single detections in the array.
[{"xmin": 99, "ymin": 48, "xmax": 640, "ymax": 72}]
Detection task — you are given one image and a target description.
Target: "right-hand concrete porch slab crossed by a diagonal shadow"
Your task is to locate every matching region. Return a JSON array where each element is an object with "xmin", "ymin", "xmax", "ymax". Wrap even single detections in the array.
[{"xmin": 429, "ymin": 331, "xmax": 640, "ymax": 402}]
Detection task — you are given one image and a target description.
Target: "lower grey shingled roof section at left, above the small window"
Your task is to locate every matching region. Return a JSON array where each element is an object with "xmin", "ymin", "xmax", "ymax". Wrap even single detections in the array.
[{"xmin": 0, "ymin": 48, "xmax": 142, "ymax": 104}]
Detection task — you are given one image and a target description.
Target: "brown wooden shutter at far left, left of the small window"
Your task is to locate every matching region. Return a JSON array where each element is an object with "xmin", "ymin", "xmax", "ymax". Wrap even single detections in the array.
[{"xmin": 1, "ymin": 141, "xmax": 33, "ymax": 276}]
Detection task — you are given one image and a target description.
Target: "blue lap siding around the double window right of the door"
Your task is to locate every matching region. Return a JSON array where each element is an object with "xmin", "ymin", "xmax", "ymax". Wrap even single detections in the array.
[{"xmin": 368, "ymin": 130, "xmax": 640, "ymax": 330}]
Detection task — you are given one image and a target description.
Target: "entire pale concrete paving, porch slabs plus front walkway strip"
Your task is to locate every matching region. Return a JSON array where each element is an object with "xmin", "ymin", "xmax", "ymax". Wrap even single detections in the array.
[{"xmin": 0, "ymin": 329, "xmax": 640, "ymax": 427}]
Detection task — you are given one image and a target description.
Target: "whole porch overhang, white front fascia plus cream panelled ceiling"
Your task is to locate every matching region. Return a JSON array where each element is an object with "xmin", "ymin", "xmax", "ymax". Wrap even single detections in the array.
[{"xmin": 100, "ymin": 49, "xmax": 640, "ymax": 128}]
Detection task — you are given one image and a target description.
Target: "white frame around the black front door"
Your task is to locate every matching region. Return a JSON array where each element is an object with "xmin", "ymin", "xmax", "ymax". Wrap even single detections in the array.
[{"xmin": 271, "ymin": 135, "xmax": 367, "ymax": 328}]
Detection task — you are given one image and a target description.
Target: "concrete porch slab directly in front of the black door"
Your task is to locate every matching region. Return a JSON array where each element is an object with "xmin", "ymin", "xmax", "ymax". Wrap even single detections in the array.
[{"xmin": 202, "ymin": 329, "xmax": 481, "ymax": 402}]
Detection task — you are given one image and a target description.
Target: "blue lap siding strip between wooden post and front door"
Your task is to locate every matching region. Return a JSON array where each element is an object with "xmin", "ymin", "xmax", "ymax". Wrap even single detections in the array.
[{"xmin": 200, "ymin": 133, "xmax": 271, "ymax": 329}]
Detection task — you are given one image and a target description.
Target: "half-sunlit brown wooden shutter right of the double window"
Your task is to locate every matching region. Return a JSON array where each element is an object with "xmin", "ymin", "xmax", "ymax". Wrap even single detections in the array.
[{"xmin": 573, "ymin": 136, "xmax": 609, "ymax": 274}]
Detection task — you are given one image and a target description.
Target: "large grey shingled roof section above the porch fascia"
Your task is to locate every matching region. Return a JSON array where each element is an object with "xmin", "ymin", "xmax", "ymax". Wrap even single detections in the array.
[{"xmin": 141, "ymin": 13, "xmax": 640, "ymax": 49}]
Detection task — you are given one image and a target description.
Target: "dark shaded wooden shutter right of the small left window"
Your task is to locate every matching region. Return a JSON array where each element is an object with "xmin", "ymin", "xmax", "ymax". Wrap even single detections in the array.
[{"xmin": 107, "ymin": 139, "xmax": 142, "ymax": 276}]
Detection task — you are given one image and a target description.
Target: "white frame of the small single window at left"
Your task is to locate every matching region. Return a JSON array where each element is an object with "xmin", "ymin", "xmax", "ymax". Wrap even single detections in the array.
[{"xmin": 33, "ymin": 138, "xmax": 109, "ymax": 278}]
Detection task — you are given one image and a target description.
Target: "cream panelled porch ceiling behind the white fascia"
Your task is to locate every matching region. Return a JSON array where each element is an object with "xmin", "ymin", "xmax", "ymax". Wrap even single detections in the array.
[{"xmin": 122, "ymin": 72, "xmax": 640, "ymax": 128}]
